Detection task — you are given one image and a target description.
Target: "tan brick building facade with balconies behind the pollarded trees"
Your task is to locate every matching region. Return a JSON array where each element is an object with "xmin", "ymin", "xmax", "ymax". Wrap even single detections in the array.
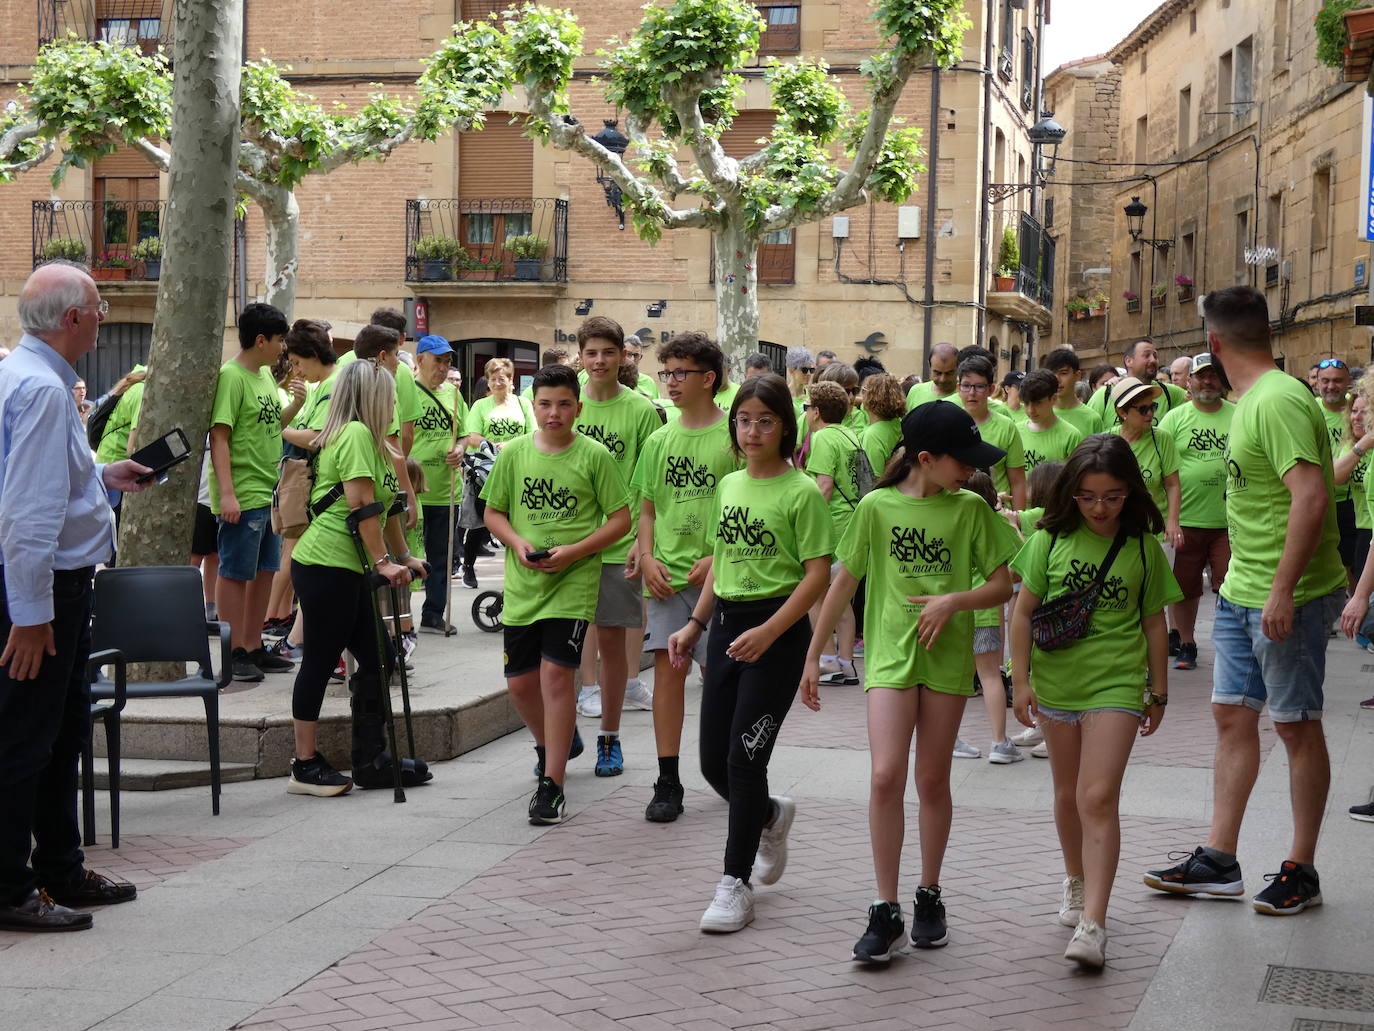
[{"xmin": 0, "ymin": 0, "xmax": 1052, "ymax": 388}]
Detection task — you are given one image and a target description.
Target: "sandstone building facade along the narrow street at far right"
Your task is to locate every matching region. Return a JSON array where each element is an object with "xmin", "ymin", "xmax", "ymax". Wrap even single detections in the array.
[{"xmin": 1050, "ymin": 0, "xmax": 1371, "ymax": 371}]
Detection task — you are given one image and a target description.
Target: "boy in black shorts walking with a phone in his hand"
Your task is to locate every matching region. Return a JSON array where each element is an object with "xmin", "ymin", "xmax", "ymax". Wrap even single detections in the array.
[{"xmin": 482, "ymin": 366, "xmax": 629, "ymax": 823}]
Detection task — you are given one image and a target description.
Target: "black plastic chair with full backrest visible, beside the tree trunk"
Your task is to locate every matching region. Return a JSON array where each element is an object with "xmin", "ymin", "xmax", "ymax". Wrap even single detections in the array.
[{"xmin": 91, "ymin": 565, "xmax": 234, "ymax": 815}]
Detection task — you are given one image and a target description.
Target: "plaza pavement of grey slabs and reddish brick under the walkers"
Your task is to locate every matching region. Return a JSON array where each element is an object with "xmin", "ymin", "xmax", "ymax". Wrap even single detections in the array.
[{"xmin": 0, "ymin": 604, "xmax": 1374, "ymax": 1031}]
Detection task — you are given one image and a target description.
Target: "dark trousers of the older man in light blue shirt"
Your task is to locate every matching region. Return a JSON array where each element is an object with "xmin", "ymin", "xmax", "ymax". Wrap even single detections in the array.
[{"xmin": 0, "ymin": 568, "xmax": 93, "ymax": 906}]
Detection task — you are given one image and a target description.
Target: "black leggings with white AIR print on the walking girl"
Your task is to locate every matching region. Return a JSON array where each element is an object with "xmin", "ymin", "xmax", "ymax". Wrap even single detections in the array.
[{"xmin": 703, "ymin": 598, "xmax": 811, "ymax": 881}]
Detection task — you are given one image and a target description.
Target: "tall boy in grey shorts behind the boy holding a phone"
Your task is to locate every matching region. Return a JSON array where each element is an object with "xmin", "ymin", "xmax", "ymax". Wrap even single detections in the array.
[{"xmin": 577, "ymin": 315, "xmax": 664, "ymax": 777}]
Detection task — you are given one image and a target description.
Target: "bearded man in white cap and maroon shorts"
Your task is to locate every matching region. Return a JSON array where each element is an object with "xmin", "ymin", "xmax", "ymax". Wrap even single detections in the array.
[{"xmin": 1158, "ymin": 352, "xmax": 1235, "ymax": 669}]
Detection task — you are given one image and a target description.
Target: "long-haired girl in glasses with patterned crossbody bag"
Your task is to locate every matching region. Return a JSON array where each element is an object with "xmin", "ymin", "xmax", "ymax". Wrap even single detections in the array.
[{"xmin": 1011, "ymin": 431, "xmax": 1183, "ymax": 969}]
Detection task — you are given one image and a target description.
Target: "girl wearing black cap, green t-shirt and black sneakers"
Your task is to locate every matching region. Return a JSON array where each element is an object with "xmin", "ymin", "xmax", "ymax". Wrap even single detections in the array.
[{"xmin": 801, "ymin": 401, "xmax": 1015, "ymax": 962}]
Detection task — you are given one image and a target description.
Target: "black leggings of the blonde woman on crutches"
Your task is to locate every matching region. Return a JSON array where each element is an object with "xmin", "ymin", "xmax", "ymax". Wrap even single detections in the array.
[{"xmin": 291, "ymin": 559, "xmax": 386, "ymax": 723}]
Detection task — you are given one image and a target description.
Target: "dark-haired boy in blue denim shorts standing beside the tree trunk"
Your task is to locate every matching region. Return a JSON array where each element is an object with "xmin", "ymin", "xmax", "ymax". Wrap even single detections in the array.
[{"xmin": 210, "ymin": 304, "xmax": 294, "ymax": 682}]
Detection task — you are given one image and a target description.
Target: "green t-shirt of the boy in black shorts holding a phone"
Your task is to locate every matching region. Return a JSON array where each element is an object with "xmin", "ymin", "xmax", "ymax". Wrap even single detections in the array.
[{"xmin": 482, "ymin": 434, "xmax": 638, "ymax": 627}]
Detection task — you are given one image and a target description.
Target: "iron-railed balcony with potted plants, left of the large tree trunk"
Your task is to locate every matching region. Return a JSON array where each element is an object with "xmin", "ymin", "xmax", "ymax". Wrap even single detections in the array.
[{"xmin": 33, "ymin": 201, "xmax": 166, "ymax": 289}]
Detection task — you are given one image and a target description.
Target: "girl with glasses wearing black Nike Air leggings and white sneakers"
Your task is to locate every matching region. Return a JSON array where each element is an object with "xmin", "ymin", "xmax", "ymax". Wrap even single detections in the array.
[{"xmin": 668, "ymin": 373, "xmax": 831, "ymax": 933}]
